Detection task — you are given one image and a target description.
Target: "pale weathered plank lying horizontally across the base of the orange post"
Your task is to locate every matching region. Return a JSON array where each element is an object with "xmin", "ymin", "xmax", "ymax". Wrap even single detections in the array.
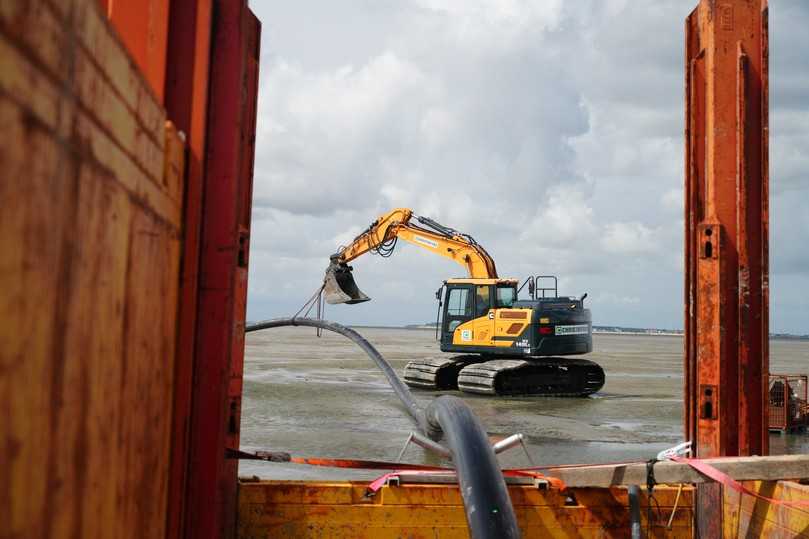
[{"xmin": 543, "ymin": 455, "xmax": 809, "ymax": 487}]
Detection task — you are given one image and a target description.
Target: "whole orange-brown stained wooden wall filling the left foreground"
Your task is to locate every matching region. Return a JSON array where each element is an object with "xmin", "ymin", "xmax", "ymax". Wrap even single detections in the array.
[{"xmin": 0, "ymin": 0, "xmax": 183, "ymax": 538}]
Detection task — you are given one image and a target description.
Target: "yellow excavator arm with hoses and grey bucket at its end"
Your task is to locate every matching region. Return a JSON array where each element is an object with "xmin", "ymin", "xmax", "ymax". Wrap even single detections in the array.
[{"xmin": 324, "ymin": 208, "xmax": 497, "ymax": 304}]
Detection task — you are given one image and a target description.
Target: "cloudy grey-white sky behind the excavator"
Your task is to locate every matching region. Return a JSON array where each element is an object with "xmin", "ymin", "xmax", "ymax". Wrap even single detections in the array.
[{"xmin": 247, "ymin": 0, "xmax": 809, "ymax": 334}]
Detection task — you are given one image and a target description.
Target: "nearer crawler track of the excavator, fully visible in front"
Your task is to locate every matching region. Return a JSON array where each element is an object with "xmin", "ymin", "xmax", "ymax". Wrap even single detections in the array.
[{"xmin": 458, "ymin": 357, "xmax": 604, "ymax": 397}]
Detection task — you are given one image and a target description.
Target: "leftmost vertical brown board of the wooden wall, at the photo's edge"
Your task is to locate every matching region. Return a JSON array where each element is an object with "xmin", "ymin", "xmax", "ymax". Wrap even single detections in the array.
[{"xmin": 0, "ymin": 94, "xmax": 77, "ymax": 537}]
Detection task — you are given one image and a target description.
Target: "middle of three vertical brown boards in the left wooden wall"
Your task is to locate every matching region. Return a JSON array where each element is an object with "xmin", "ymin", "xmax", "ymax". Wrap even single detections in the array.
[{"xmin": 48, "ymin": 162, "xmax": 129, "ymax": 537}]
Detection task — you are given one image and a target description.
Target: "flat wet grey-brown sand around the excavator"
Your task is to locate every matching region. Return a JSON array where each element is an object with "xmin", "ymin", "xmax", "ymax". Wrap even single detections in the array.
[{"xmin": 240, "ymin": 328, "xmax": 809, "ymax": 479}]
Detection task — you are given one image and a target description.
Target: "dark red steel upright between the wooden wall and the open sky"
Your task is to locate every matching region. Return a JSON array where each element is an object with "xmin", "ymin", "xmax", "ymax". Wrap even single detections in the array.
[{"xmin": 185, "ymin": 0, "xmax": 260, "ymax": 538}]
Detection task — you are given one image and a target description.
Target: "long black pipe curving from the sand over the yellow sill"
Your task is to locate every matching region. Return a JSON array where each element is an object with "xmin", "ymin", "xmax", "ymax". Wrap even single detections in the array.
[{"xmin": 245, "ymin": 318, "xmax": 520, "ymax": 539}]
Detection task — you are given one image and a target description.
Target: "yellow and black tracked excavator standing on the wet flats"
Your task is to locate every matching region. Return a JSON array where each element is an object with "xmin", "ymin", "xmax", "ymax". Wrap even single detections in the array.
[{"xmin": 323, "ymin": 208, "xmax": 604, "ymax": 397}]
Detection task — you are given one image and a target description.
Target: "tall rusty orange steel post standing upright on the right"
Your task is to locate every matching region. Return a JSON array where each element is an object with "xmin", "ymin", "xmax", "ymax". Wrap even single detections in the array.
[{"xmin": 684, "ymin": 0, "xmax": 769, "ymax": 537}]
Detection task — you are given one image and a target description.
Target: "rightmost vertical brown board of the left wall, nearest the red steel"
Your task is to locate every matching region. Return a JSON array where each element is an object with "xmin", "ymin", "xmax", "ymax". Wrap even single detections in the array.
[{"xmin": 117, "ymin": 210, "xmax": 179, "ymax": 537}]
